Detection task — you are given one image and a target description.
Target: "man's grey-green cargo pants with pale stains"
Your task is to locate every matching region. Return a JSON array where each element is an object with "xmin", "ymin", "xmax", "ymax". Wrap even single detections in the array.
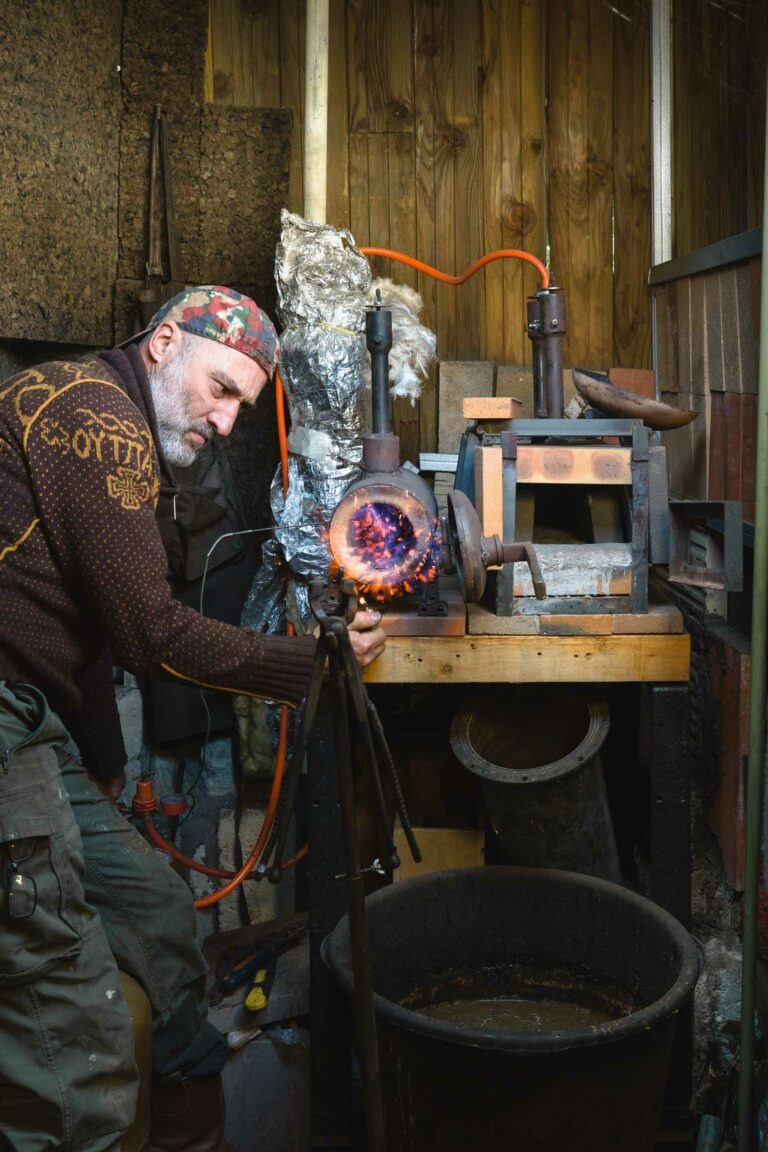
[{"xmin": 0, "ymin": 681, "xmax": 227, "ymax": 1152}]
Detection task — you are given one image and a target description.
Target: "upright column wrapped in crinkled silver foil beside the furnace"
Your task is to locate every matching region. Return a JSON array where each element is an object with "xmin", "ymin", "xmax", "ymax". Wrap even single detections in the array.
[{"xmin": 243, "ymin": 210, "xmax": 371, "ymax": 631}]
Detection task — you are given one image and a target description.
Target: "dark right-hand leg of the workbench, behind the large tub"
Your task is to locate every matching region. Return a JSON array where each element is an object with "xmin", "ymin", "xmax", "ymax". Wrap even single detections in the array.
[{"xmin": 640, "ymin": 684, "xmax": 693, "ymax": 1126}]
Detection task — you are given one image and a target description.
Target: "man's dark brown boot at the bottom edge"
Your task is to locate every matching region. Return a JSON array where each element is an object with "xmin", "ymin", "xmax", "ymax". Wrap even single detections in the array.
[{"xmin": 147, "ymin": 1073, "xmax": 231, "ymax": 1152}]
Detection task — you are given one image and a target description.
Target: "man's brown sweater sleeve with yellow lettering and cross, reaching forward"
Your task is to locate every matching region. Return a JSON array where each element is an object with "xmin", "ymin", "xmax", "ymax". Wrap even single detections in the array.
[{"xmin": 24, "ymin": 380, "xmax": 315, "ymax": 705}]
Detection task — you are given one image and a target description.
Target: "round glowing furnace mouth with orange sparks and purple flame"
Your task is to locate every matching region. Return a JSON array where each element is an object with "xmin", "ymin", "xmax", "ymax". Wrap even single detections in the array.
[{"xmin": 329, "ymin": 483, "xmax": 442, "ymax": 601}]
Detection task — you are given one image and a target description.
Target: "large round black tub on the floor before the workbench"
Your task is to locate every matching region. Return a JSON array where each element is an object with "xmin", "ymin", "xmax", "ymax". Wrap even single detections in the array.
[{"xmin": 322, "ymin": 866, "xmax": 699, "ymax": 1152}]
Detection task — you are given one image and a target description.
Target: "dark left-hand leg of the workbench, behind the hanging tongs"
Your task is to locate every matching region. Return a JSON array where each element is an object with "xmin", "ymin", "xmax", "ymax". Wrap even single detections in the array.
[{"xmin": 306, "ymin": 689, "xmax": 351, "ymax": 1150}]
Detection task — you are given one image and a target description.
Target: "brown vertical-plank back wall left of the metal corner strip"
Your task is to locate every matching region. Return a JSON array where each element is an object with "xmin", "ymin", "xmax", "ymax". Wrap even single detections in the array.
[{"xmin": 207, "ymin": 0, "xmax": 651, "ymax": 448}]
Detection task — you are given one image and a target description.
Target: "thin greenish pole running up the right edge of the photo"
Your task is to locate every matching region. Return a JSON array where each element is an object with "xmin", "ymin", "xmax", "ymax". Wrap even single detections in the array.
[{"xmin": 737, "ymin": 74, "xmax": 768, "ymax": 1152}]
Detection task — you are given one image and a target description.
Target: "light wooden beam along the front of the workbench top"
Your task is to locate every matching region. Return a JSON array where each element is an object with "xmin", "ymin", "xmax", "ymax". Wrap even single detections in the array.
[{"xmin": 364, "ymin": 632, "xmax": 691, "ymax": 684}]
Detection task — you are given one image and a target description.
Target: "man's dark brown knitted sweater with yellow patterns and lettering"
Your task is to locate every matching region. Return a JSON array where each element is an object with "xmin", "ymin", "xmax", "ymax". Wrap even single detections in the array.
[{"xmin": 0, "ymin": 348, "xmax": 315, "ymax": 711}]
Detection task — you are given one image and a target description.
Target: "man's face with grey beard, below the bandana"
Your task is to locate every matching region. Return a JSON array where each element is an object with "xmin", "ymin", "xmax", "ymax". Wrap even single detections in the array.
[{"xmin": 150, "ymin": 333, "xmax": 267, "ymax": 467}]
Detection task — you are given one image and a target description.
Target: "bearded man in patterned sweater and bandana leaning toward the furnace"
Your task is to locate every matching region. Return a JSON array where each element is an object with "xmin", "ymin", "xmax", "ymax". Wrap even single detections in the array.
[{"xmin": 0, "ymin": 286, "xmax": 385, "ymax": 1152}]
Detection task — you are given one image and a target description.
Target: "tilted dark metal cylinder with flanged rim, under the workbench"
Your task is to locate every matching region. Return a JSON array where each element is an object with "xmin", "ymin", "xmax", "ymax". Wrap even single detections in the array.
[{"xmin": 450, "ymin": 684, "xmax": 621, "ymax": 882}]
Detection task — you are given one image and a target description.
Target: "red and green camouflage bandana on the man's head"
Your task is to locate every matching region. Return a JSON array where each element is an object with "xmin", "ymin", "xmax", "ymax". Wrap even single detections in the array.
[{"xmin": 141, "ymin": 285, "xmax": 277, "ymax": 379}]
